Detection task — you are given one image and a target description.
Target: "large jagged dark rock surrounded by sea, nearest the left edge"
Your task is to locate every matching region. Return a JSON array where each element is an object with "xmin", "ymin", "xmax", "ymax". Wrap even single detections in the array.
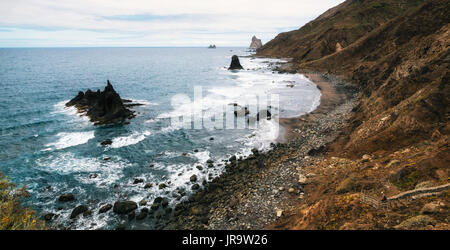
[{"xmin": 66, "ymin": 80, "xmax": 140, "ymax": 125}]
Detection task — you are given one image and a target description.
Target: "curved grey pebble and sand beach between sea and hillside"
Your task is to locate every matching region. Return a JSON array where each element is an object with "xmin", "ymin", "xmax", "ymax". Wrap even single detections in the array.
[{"xmin": 164, "ymin": 63, "xmax": 356, "ymax": 229}]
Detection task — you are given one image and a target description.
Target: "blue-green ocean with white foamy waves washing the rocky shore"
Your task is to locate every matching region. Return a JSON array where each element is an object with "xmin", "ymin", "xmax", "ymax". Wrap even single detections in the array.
[{"xmin": 0, "ymin": 48, "xmax": 320, "ymax": 229}]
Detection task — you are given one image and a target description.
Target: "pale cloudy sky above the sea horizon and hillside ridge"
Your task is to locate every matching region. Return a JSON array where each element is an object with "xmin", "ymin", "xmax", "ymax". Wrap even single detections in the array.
[{"xmin": 0, "ymin": 0, "xmax": 343, "ymax": 47}]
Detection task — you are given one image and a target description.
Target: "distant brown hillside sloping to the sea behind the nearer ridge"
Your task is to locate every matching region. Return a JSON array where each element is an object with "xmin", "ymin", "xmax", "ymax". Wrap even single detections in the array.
[{"xmin": 258, "ymin": 0, "xmax": 424, "ymax": 62}]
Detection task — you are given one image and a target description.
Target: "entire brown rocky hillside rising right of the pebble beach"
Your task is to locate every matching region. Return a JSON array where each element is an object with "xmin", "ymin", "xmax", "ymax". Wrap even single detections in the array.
[{"xmin": 258, "ymin": 0, "xmax": 450, "ymax": 229}]
